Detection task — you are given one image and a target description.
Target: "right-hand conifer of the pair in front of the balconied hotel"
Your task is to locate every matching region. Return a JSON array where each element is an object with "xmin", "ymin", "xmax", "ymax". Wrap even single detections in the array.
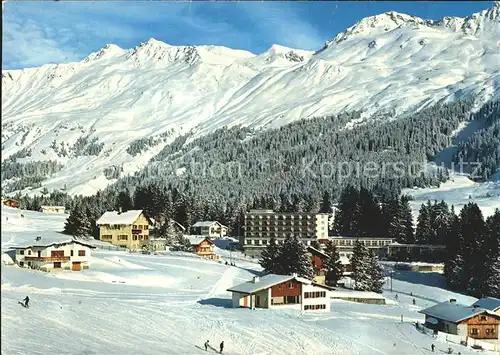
[{"xmin": 280, "ymin": 235, "xmax": 314, "ymax": 280}]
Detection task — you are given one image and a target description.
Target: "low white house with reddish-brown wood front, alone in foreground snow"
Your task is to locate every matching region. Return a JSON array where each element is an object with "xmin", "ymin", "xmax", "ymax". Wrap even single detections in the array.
[{"xmin": 228, "ymin": 274, "xmax": 330, "ymax": 312}]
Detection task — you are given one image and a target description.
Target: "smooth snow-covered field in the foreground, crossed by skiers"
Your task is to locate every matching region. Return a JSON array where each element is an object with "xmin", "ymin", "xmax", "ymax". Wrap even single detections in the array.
[{"xmin": 1, "ymin": 206, "xmax": 496, "ymax": 355}]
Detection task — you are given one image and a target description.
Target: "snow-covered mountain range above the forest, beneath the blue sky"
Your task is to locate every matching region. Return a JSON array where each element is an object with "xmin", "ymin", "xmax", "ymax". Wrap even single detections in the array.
[{"xmin": 2, "ymin": 2, "xmax": 500, "ymax": 194}]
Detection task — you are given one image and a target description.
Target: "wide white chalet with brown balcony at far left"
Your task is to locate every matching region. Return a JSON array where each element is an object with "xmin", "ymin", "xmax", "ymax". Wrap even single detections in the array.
[{"xmin": 14, "ymin": 237, "xmax": 94, "ymax": 271}]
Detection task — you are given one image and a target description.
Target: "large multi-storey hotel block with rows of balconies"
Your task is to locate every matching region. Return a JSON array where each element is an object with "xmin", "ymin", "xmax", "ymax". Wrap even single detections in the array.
[{"xmin": 242, "ymin": 210, "xmax": 329, "ymax": 257}]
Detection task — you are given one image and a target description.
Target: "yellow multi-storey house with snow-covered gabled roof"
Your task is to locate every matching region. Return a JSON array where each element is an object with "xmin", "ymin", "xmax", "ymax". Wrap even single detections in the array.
[{"xmin": 96, "ymin": 210, "xmax": 151, "ymax": 250}]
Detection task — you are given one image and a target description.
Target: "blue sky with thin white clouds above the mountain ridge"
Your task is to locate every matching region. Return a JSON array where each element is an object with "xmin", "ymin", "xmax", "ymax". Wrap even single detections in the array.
[{"xmin": 2, "ymin": 1, "xmax": 493, "ymax": 69}]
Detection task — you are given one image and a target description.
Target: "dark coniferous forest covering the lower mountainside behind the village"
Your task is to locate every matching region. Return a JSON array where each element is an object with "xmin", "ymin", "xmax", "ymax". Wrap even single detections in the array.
[{"xmin": 2, "ymin": 100, "xmax": 500, "ymax": 296}]
